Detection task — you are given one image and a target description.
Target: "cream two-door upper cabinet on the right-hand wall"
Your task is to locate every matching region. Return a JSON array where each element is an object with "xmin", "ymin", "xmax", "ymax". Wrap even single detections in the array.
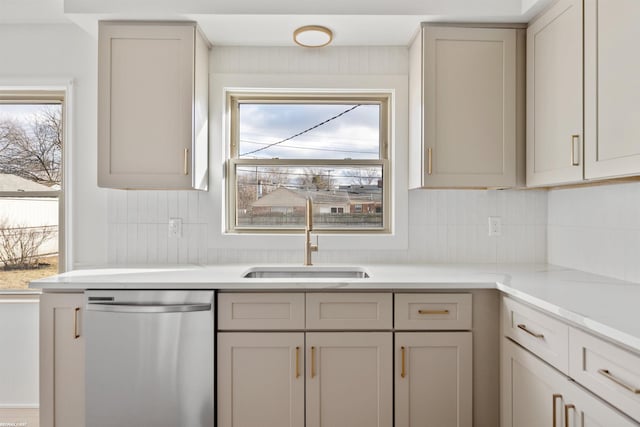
[{"xmin": 527, "ymin": 0, "xmax": 640, "ymax": 186}]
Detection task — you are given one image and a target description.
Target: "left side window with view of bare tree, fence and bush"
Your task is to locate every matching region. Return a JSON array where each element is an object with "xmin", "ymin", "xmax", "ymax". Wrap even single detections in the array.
[{"xmin": 0, "ymin": 92, "xmax": 64, "ymax": 289}]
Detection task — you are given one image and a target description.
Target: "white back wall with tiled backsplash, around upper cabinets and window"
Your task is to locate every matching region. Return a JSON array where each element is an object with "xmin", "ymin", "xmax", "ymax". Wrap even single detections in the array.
[{"xmin": 0, "ymin": 29, "xmax": 546, "ymax": 268}]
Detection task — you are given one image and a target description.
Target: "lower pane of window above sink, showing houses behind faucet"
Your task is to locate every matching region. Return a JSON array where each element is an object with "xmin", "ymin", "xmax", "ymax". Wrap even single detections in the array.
[{"xmin": 236, "ymin": 165, "xmax": 384, "ymax": 229}]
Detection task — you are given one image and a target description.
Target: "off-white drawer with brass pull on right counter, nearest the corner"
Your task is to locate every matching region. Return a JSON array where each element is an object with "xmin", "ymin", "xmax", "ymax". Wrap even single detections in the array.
[{"xmin": 502, "ymin": 298, "xmax": 569, "ymax": 374}]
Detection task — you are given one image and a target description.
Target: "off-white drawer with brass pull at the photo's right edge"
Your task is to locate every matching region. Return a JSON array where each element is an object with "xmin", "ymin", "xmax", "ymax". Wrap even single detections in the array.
[{"xmin": 569, "ymin": 328, "xmax": 640, "ymax": 421}]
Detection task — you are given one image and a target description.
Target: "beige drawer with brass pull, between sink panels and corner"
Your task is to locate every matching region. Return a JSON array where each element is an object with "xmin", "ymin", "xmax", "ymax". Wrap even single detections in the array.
[{"xmin": 395, "ymin": 294, "xmax": 472, "ymax": 330}]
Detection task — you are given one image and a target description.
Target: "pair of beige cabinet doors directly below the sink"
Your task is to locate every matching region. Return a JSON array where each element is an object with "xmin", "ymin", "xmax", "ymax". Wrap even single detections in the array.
[{"xmin": 217, "ymin": 332, "xmax": 393, "ymax": 427}]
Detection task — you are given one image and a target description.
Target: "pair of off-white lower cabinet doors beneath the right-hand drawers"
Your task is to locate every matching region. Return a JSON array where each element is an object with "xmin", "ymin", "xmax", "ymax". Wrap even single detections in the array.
[{"xmin": 501, "ymin": 338, "xmax": 638, "ymax": 427}]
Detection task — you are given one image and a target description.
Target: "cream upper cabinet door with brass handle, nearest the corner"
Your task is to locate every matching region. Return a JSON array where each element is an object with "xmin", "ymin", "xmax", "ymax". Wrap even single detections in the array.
[{"xmin": 527, "ymin": 0, "xmax": 583, "ymax": 186}]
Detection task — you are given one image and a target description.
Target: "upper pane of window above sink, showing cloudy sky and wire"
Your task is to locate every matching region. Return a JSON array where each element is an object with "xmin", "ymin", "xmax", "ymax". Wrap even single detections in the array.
[{"xmin": 238, "ymin": 103, "xmax": 380, "ymax": 159}]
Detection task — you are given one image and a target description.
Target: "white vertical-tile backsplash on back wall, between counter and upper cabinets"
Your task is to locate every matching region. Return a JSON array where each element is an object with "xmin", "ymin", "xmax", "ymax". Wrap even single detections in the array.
[{"xmin": 108, "ymin": 190, "xmax": 547, "ymax": 264}]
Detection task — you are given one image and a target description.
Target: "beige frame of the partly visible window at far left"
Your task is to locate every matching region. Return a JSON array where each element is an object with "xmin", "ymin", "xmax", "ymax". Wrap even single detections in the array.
[{"xmin": 0, "ymin": 92, "xmax": 69, "ymax": 273}]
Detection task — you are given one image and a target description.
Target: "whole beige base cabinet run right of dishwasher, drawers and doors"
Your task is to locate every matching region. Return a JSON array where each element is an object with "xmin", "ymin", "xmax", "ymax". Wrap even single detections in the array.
[{"xmin": 216, "ymin": 292, "xmax": 476, "ymax": 427}]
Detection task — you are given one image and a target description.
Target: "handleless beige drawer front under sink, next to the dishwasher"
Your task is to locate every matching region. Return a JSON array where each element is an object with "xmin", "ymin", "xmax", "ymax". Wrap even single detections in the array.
[{"xmin": 218, "ymin": 293, "xmax": 304, "ymax": 330}]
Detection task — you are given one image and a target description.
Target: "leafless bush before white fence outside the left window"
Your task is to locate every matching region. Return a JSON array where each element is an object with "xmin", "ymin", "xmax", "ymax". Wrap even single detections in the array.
[{"xmin": 0, "ymin": 219, "xmax": 56, "ymax": 270}]
